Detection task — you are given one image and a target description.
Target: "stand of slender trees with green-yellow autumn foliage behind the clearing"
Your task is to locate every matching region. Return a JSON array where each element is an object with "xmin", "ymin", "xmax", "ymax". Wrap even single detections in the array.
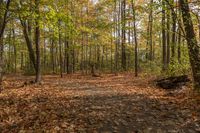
[{"xmin": 0, "ymin": 0, "xmax": 200, "ymax": 91}]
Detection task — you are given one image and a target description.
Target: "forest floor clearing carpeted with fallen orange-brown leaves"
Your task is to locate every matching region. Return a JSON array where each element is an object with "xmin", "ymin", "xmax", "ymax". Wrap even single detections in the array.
[{"xmin": 0, "ymin": 74, "xmax": 200, "ymax": 133}]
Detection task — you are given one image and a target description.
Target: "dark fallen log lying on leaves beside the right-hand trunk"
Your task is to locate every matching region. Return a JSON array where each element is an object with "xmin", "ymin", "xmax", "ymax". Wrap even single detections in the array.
[{"xmin": 156, "ymin": 75, "xmax": 190, "ymax": 89}]
